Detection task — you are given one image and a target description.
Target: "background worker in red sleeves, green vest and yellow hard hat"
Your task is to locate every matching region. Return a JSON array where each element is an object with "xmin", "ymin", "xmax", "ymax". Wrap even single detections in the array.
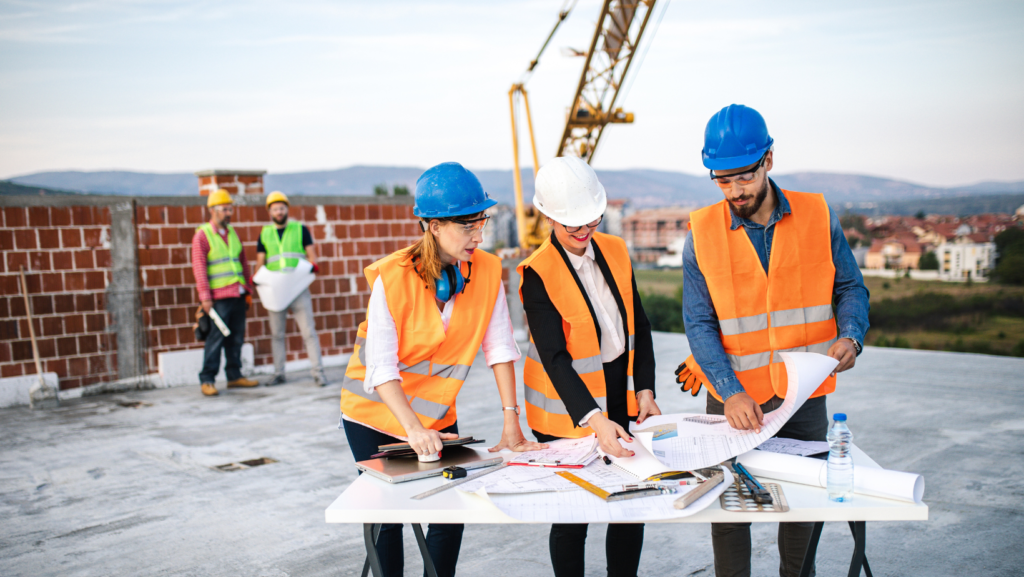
[{"xmin": 193, "ymin": 189, "xmax": 259, "ymax": 397}]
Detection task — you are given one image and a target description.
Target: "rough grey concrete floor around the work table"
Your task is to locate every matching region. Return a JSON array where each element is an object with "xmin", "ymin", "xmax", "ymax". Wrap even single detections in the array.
[{"xmin": 0, "ymin": 334, "xmax": 1024, "ymax": 577}]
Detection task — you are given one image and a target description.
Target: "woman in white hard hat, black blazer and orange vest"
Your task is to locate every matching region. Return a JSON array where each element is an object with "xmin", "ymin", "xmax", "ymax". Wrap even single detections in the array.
[{"xmin": 518, "ymin": 157, "xmax": 662, "ymax": 577}]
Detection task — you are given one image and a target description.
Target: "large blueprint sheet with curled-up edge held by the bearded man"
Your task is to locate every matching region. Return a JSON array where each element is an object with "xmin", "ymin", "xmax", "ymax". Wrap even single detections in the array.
[{"xmin": 630, "ymin": 353, "xmax": 839, "ymax": 470}]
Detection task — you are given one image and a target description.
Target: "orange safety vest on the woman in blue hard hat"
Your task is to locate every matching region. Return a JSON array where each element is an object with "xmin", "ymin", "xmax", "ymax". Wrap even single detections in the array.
[{"xmin": 341, "ymin": 249, "xmax": 502, "ymax": 437}]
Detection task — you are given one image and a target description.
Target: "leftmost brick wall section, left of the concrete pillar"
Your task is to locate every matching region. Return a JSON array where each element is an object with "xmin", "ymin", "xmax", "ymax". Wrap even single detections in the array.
[{"xmin": 0, "ymin": 206, "xmax": 117, "ymax": 388}]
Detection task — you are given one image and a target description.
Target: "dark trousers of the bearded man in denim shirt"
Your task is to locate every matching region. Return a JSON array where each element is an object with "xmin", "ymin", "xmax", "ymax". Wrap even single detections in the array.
[{"xmin": 708, "ymin": 395, "xmax": 828, "ymax": 577}]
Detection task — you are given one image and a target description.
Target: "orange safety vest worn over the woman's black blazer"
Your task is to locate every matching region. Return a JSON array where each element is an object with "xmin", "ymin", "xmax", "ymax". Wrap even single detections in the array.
[{"xmin": 517, "ymin": 233, "xmax": 638, "ymax": 439}]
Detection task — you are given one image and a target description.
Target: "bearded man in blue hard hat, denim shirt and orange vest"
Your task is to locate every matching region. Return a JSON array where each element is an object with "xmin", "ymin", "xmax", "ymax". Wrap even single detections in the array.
[{"xmin": 676, "ymin": 105, "xmax": 868, "ymax": 577}]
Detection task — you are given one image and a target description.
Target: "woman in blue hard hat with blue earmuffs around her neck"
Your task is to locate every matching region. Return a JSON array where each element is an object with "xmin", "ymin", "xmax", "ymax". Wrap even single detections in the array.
[{"xmin": 341, "ymin": 162, "xmax": 546, "ymax": 577}]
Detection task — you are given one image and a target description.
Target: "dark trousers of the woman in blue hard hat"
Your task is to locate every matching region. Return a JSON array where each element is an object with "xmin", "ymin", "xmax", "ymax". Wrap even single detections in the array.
[{"xmin": 341, "ymin": 419, "xmax": 465, "ymax": 577}]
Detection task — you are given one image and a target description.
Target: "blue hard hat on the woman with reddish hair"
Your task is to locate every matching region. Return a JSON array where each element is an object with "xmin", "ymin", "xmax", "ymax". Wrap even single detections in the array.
[{"xmin": 413, "ymin": 162, "xmax": 498, "ymax": 218}]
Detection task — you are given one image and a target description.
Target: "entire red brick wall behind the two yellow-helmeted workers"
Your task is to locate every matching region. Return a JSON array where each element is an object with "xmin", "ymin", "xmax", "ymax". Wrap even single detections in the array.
[{"xmin": 0, "ymin": 195, "xmax": 419, "ymax": 389}]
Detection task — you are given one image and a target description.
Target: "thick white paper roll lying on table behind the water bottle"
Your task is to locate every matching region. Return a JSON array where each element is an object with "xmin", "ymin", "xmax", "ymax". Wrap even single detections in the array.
[{"xmin": 736, "ymin": 451, "xmax": 925, "ymax": 503}]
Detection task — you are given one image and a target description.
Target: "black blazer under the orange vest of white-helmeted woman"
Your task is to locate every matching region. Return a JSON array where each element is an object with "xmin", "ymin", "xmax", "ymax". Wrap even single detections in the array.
[{"xmin": 522, "ymin": 235, "xmax": 654, "ymax": 426}]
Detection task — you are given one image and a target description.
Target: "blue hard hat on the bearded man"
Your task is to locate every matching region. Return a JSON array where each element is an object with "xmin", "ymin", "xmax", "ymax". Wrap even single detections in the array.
[{"xmin": 700, "ymin": 105, "xmax": 775, "ymax": 170}]
